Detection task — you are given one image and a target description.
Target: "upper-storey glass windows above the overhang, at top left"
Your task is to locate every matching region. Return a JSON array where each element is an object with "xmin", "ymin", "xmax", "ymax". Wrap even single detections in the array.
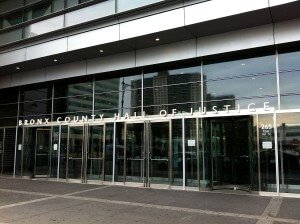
[{"xmin": 0, "ymin": 0, "xmax": 172, "ymax": 45}]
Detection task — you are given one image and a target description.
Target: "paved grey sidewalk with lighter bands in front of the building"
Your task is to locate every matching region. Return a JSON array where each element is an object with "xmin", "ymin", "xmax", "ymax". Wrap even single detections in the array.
[{"xmin": 0, "ymin": 178, "xmax": 300, "ymax": 224}]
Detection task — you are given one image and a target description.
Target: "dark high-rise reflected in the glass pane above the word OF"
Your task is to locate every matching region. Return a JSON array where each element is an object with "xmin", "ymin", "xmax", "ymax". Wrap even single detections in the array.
[{"xmin": 144, "ymin": 71, "xmax": 201, "ymax": 114}]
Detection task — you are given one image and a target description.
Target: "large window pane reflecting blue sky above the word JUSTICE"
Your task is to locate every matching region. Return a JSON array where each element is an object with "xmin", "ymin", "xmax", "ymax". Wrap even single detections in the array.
[{"xmin": 203, "ymin": 55, "xmax": 277, "ymax": 110}]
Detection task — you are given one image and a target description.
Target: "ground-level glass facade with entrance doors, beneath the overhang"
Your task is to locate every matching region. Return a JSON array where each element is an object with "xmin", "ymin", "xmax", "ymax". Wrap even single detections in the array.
[{"xmin": 0, "ymin": 48, "xmax": 300, "ymax": 193}]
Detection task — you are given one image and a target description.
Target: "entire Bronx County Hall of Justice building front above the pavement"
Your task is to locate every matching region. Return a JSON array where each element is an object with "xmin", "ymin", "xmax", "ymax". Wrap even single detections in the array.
[{"xmin": 0, "ymin": 0, "xmax": 300, "ymax": 196}]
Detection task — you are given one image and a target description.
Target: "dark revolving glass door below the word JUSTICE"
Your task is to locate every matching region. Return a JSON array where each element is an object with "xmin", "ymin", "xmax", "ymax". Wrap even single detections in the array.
[{"xmin": 210, "ymin": 118, "xmax": 251, "ymax": 190}]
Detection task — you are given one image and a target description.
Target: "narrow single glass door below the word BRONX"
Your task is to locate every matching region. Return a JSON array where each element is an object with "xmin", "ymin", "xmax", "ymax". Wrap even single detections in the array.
[{"xmin": 34, "ymin": 128, "xmax": 51, "ymax": 178}]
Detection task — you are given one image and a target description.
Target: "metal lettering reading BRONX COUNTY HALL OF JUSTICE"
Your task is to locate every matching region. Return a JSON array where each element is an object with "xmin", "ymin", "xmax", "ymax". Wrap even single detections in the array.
[{"xmin": 18, "ymin": 102, "xmax": 272, "ymax": 126}]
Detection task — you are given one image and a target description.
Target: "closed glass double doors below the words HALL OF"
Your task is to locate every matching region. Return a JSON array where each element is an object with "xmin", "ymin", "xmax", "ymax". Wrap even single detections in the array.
[{"xmin": 125, "ymin": 121, "xmax": 171, "ymax": 187}]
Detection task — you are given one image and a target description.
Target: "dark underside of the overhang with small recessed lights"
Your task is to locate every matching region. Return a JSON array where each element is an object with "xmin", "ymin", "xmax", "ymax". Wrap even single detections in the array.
[{"xmin": 0, "ymin": 1, "xmax": 300, "ymax": 75}]
